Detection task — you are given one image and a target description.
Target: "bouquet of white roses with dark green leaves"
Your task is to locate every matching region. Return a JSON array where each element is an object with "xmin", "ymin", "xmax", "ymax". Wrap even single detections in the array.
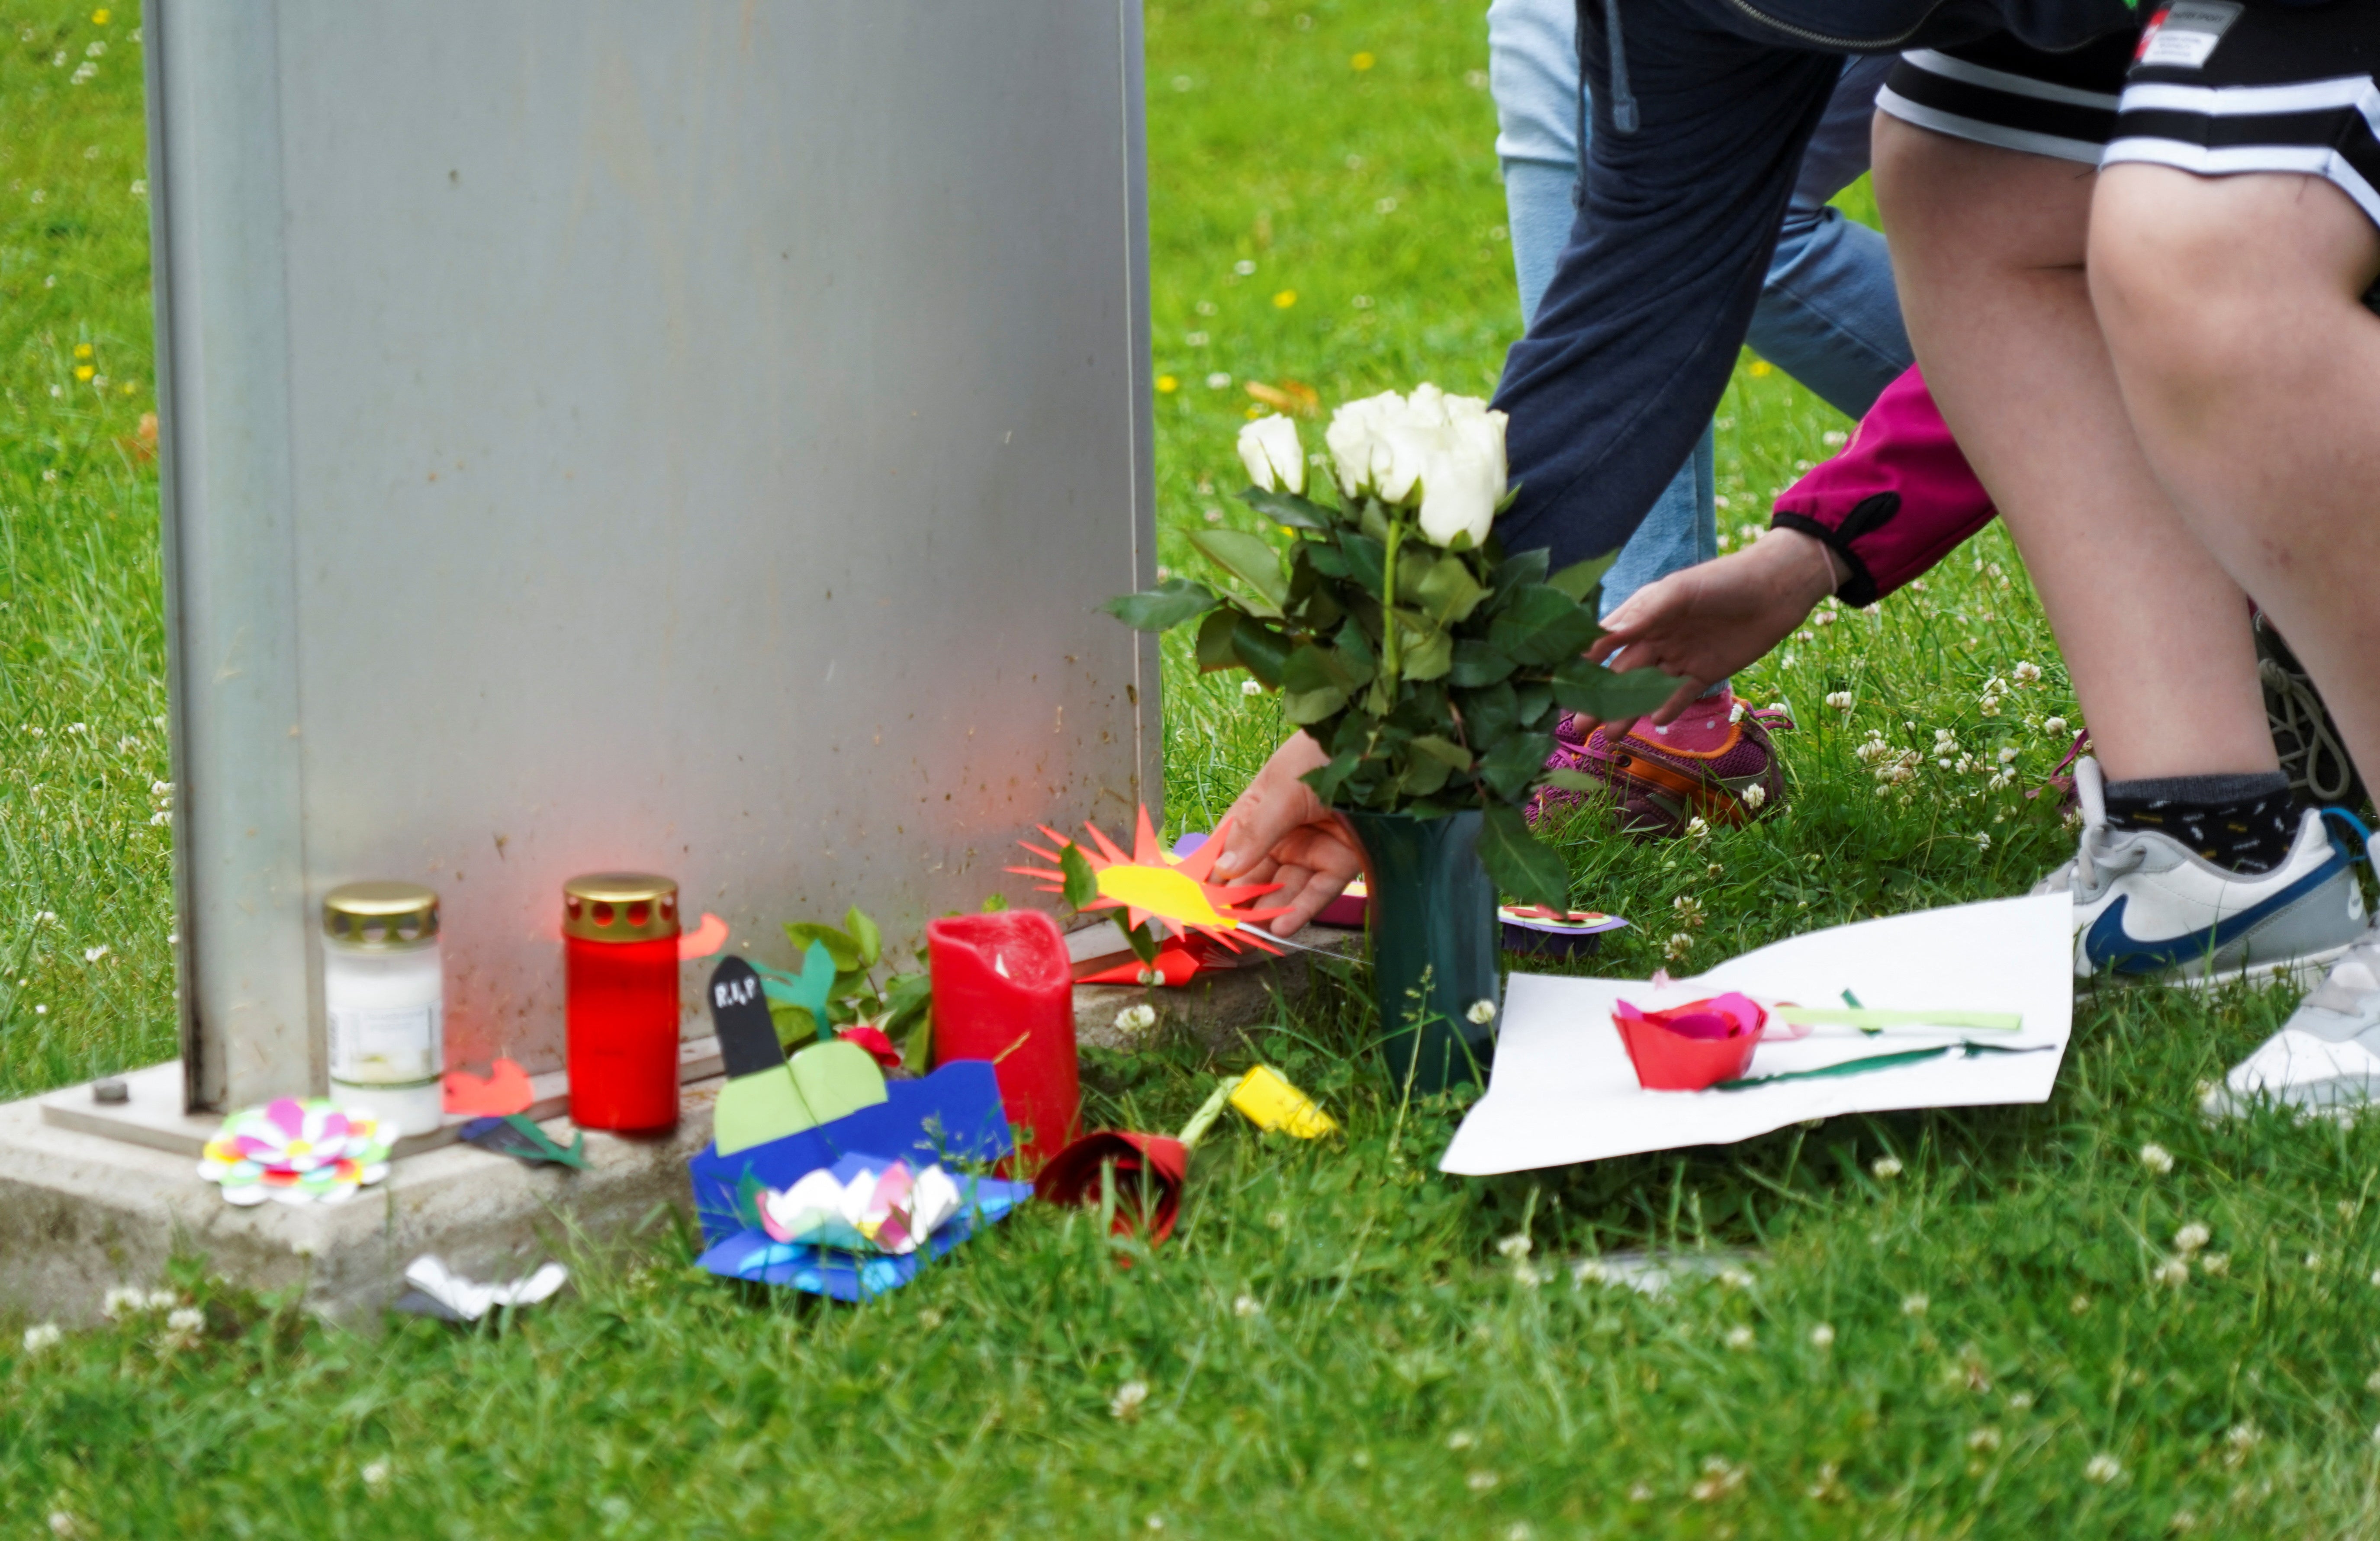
[{"xmin": 1107, "ymin": 386, "xmax": 1678, "ymax": 907}]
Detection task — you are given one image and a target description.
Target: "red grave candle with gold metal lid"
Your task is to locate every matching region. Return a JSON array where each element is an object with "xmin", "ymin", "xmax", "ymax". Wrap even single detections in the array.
[{"xmin": 562, "ymin": 872, "xmax": 679, "ymax": 1131}]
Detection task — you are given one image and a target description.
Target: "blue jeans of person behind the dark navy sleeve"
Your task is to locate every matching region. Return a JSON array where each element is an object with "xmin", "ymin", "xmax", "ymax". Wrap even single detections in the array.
[{"xmin": 1488, "ymin": 0, "xmax": 1914, "ymax": 614}]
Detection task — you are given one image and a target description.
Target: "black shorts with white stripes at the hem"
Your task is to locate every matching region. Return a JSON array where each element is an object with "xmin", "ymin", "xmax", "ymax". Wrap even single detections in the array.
[{"xmin": 1875, "ymin": 0, "xmax": 2380, "ymax": 224}]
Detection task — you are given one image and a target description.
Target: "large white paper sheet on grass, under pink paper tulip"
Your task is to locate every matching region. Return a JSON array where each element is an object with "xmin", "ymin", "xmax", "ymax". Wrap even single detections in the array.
[{"xmin": 1438, "ymin": 893, "xmax": 2075, "ymax": 1177}]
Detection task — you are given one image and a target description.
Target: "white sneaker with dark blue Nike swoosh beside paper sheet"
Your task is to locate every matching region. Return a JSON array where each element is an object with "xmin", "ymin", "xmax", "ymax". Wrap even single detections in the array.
[{"xmin": 2033, "ymin": 757, "xmax": 2366, "ymax": 984}]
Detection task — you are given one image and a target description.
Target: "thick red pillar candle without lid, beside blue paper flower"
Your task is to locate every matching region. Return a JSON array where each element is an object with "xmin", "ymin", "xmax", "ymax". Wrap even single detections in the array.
[{"xmin": 926, "ymin": 910, "xmax": 1083, "ymax": 1172}]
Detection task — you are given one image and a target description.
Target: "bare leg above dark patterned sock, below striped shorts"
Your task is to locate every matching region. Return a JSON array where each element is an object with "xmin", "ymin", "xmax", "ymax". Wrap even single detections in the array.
[{"xmin": 1875, "ymin": 114, "xmax": 2275, "ymax": 779}]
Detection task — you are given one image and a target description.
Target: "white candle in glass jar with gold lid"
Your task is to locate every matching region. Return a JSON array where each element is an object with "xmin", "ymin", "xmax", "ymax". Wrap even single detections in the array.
[{"xmin": 322, "ymin": 884, "xmax": 445, "ymax": 1134}]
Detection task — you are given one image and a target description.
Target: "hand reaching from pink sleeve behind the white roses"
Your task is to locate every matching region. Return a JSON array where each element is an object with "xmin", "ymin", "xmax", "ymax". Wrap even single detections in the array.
[{"xmin": 1580, "ymin": 529, "xmax": 1842, "ymax": 738}]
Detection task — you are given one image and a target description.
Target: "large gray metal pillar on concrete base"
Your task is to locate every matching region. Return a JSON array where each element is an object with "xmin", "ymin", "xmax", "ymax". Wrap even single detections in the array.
[{"xmin": 145, "ymin": 0, "xmax": 1161, "ymax": 1107}]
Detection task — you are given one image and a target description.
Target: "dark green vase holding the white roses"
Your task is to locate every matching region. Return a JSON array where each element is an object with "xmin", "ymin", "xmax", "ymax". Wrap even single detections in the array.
[{"xmin": 1347, "ymin": 812, "xmax": 1504, "ymax": 1093}]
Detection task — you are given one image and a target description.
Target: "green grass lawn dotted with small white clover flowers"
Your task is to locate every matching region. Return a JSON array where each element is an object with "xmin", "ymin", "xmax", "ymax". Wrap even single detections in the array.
[{"xmin": 0, "ymin": 0, "xmax": 2380, "ymax": 1538}]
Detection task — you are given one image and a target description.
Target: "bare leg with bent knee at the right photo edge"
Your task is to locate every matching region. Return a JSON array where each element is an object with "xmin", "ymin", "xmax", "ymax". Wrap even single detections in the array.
[{"xmin": 2090, "ymin": 164, "xmax": 2380, "ymax": 795}]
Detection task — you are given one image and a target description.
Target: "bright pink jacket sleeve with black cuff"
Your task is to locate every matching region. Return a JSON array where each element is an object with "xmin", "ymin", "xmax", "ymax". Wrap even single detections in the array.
[{"xmin": 1771, "ymin": 367, "xmax": 1994, "ymax": 605}]
